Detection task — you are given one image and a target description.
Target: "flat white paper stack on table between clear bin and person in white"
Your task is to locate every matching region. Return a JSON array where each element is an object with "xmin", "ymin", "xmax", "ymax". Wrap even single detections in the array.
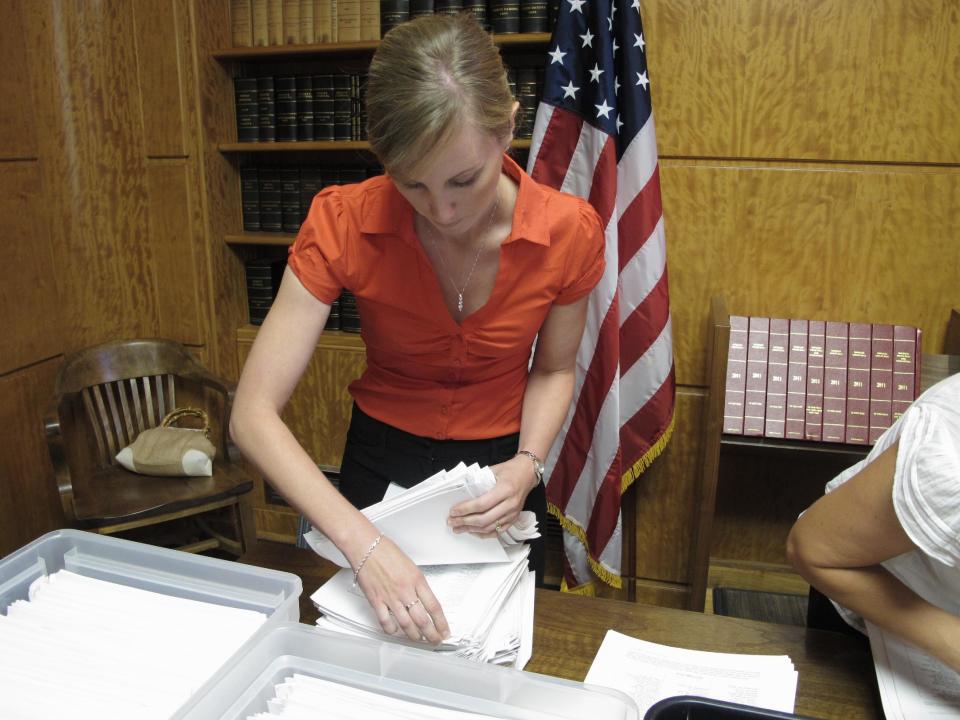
[{"xmin": 584, "ymin": 630, "xmax": 797, "ymax": 714}]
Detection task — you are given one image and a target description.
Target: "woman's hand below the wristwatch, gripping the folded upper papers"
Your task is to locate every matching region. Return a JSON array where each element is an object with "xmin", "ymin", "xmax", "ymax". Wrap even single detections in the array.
[{"xmin": 447, "ymin": 455, "xmax": 537, "ymax": 537}]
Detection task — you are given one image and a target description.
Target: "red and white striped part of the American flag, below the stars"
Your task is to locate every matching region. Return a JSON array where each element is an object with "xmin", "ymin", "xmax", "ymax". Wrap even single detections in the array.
[{"xmin": 529, "ymin": 98, "xmax": 674, "ymax": 589}]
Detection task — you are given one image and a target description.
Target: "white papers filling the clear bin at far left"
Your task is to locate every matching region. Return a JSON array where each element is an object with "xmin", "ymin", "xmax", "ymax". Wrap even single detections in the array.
[{"xmin": 0, "ymin": 570, "xmax": 266, "ymax": 720}]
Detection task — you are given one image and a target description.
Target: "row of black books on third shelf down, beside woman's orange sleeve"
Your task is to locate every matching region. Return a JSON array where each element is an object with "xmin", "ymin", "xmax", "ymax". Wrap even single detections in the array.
[{"xmin": 240, "ymin": 166, "xmax": 382, "ymax": 233}]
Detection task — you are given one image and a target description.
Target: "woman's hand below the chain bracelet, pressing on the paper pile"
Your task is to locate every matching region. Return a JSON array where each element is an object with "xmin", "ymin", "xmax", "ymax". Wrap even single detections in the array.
[{"xmin": 357, "ymin": 536, "xmax": 450, "ymax": 645}]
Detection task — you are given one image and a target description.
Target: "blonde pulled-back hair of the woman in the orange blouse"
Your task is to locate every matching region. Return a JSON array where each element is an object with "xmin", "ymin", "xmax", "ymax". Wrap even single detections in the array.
[{"xmin": 366, "ymin": 13, "xmax": 513, "ymax": 174}]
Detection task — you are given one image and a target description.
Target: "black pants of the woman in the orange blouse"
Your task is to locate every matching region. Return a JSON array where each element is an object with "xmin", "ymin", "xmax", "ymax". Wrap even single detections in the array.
[{"xmin": 340, "ymin": 404, "xmax": 547, "ymax": 587}]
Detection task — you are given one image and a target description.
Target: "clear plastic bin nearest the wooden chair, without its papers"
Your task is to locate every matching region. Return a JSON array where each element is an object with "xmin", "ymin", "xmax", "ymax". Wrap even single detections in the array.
[{"xmin": 0, "ymin": 530, "xmax": 303, "ymax": 625}]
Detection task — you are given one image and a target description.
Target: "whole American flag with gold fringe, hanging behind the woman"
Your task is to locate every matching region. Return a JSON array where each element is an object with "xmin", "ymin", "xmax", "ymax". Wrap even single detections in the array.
[{"xmin": 528, "ymin": 0, "xmax": 674, "ymax": 592}]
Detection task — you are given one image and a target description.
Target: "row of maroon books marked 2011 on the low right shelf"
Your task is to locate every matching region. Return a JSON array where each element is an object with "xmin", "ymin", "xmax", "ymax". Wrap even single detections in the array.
[{"xmin": 723, "ymin": 315, "xmax": 920, "ymax": 445}]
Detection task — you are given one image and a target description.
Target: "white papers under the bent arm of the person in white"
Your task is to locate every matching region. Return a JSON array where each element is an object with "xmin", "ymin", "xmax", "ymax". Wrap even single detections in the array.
[{"xmin": 866, "ymin": 620, "xmax": 960, "ymax": 720}]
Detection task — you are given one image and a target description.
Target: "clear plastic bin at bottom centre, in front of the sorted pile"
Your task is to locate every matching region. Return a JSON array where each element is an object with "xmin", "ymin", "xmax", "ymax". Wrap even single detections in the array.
[{"xmin": 174, "ymin": 623, "xmax": 639, "ymax": 720}]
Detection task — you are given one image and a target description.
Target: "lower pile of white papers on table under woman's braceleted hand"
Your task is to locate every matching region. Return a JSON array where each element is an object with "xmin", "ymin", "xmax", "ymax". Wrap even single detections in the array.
[{"xmin": 310, "ymin": 544, "xmax": 534, "ymax": 669}]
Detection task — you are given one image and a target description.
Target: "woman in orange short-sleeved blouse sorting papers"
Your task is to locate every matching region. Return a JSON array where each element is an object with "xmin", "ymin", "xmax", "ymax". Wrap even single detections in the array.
[{"xmin": 231, "ymin": 16, "xmax": 604, "ymax": 643}]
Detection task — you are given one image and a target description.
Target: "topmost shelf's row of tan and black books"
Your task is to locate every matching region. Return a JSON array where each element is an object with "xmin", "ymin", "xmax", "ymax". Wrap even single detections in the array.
[{"xmin": 230, "ymin": 0, "xmax": 560, "ymax": 47}]
